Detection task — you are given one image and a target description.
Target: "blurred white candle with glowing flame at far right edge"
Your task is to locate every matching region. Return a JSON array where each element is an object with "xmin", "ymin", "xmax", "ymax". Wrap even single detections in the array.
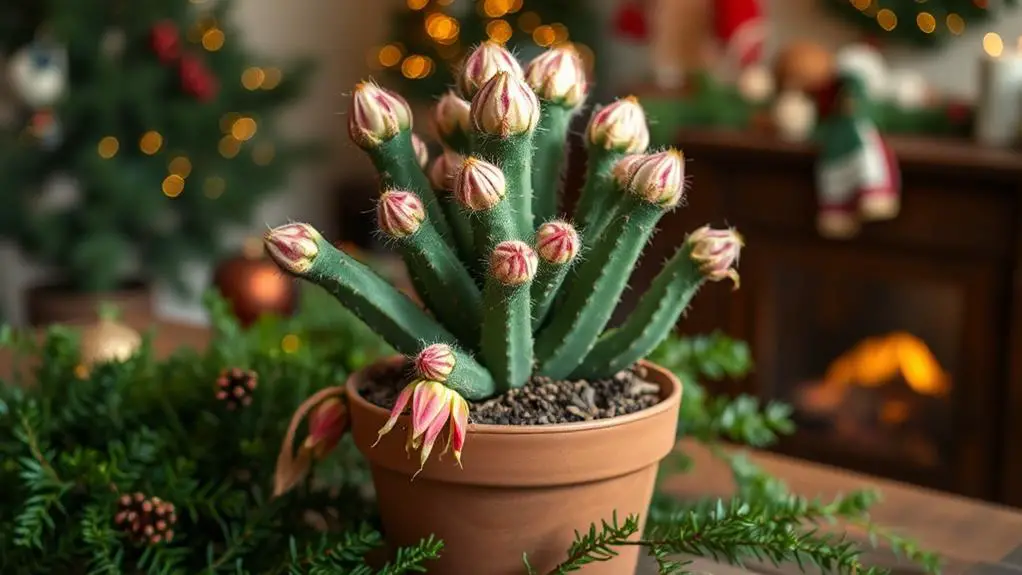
[{"xmin": 976, "ymin": 32, "xmax": 1022, "ymax": 147}]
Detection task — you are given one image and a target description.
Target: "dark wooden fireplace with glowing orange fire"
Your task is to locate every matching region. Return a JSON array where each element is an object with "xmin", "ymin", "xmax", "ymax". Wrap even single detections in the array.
[{"xmin": 621, "ymin": 132, "xmax": 1022, "ymax": 506}]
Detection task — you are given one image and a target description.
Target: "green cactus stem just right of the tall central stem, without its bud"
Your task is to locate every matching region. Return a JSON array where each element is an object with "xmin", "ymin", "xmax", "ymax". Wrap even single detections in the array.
[{"xmin": 532, "ymin": 105, "xmax": 574, "ymax": 222}]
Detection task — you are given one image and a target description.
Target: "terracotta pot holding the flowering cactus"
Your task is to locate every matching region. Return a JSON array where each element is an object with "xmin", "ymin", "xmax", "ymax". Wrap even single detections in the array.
[{"xmin": 347, "ymin": 357, "xmax": 682, "ymax": 575}]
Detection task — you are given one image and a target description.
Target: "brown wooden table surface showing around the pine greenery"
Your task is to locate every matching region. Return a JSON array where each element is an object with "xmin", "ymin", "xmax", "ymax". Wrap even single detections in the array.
[{"xmin": 0, "ymin": 323, "xmax": 1022, "ymax": 575}]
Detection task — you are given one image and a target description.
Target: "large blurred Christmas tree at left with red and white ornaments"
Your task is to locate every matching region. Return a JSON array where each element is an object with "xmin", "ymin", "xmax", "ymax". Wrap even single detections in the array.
[{"xmin": 0, "ymin": 0, "xmax": 309, "ymax": 291}]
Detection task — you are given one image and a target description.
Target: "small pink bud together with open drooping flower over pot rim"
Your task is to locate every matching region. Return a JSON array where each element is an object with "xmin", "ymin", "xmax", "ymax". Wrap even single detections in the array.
[{"xmin": 376, "ymin": 343, "xmax": 468, "ymax": 471}]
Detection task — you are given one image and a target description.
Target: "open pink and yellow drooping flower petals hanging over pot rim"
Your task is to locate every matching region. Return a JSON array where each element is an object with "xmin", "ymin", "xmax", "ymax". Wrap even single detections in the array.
[{"xmin": 373, "ymin": 379, "xmax": 468, "ymax": 472}]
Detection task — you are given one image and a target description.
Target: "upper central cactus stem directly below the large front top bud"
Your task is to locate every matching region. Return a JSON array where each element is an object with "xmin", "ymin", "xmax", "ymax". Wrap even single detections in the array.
[{"xmin": 472, "ymin": 132, "xmax": 533, "ymax": 238}]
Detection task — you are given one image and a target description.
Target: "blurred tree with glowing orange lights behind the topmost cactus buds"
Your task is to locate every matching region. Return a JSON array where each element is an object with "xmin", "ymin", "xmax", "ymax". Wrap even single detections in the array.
[{"xmin": 368, "ymin": 0, "xmax": 600, "ymax": 100}]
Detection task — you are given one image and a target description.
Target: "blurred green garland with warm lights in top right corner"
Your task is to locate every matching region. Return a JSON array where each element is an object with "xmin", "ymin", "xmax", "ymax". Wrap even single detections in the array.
[{"xmin": 823, "ymin": 0, "xmax": 1018, "ymax": 45}]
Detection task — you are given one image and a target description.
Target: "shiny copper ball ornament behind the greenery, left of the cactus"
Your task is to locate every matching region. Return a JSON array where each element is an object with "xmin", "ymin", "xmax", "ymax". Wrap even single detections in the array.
[{"xmin": 213, "ymin": 240, "xmax": 298, "ymax": 326}]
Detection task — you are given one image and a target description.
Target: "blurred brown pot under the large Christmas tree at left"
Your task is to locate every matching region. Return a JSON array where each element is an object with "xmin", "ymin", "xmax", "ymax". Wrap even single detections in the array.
[{"xmin": 26, "ymin": 282, "xmax": 152, "ymax": 326}]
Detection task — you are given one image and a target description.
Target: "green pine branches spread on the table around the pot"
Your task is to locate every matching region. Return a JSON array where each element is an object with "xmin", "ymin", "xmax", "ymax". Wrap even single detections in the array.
[{"xmin": 0, "ymin": 287, "xmax": 936, "ymax": 575}]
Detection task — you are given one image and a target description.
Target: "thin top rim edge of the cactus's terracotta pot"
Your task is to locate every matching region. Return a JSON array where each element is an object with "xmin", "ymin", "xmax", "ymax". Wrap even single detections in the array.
[{"xmin": 344, "ymin": 355, "xmax": 682, "ymax": 435}]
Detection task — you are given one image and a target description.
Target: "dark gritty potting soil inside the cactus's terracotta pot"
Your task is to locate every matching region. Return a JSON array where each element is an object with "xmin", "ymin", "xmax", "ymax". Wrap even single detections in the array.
[{"xmin": 360, "ymin": 364, "xmax": 660, "ymax": 425}]
